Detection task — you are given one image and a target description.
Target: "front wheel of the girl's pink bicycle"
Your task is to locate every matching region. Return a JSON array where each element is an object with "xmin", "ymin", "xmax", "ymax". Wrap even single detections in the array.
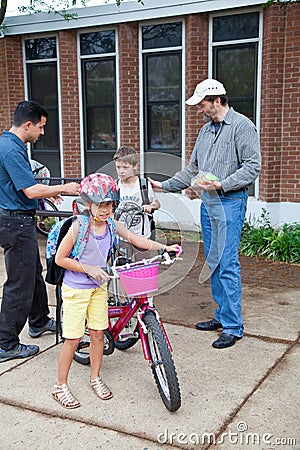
[{"xmin": 143, "ymin": 312, "xmax": 181, "ymax": 412}]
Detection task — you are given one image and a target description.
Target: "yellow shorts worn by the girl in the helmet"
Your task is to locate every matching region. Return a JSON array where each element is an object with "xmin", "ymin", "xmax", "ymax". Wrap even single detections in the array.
[{"xmin": 62, "ymin": 283, "xmax": 108, "ymax": 339}]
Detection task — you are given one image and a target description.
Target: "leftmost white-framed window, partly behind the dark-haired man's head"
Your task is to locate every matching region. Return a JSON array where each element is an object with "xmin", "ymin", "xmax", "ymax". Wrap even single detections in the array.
[{"xmin": 24, "ymin": 36, "xmax": 60, "ymax": 177}]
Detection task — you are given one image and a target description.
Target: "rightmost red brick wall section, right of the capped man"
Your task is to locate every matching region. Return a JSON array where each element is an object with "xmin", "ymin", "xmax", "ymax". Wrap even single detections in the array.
[{"xmin": 259, "ymin": 4, "xmax": 300, "ymax": 202}]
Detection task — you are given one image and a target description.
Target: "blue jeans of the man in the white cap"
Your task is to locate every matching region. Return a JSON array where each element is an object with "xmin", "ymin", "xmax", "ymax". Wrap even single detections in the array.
[{"xmin": 201, "ymin": 190, "xmax": 248, "ymax": 337}]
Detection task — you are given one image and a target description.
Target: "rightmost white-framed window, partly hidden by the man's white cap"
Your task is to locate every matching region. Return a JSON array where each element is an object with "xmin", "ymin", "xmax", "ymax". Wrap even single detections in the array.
[{"xmin": 210, "ymin": 11, "xmax": 260, "ymax": 195}]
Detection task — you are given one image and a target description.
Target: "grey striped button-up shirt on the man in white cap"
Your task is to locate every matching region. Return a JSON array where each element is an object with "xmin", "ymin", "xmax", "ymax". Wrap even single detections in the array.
[{"xmin": 162, "ymin": 108, "xmax": 261, "ymax": 192}]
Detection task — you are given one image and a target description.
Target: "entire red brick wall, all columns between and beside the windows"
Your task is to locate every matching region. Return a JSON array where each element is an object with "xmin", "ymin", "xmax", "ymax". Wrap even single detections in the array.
[{"xmin": 0, "ymin": 3, "xmax": 300, "ymax": 202}]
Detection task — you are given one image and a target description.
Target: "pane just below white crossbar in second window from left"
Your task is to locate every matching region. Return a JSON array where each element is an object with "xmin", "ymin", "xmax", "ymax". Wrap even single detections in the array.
[{"xmin": 84, "ymin": 59, "xmax": 115, "ymax": 105}]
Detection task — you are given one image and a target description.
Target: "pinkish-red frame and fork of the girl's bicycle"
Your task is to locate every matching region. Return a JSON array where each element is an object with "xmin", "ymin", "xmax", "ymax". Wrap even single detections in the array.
[{"xmin": 108, "ymin": 295, "xmax": 172, "ymax": 361}]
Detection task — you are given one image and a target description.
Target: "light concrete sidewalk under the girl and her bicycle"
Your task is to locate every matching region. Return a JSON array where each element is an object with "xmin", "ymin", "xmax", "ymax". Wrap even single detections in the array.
[{"xmin": 0, "ymin": 237, "xmax": 300, "ymax": 450}]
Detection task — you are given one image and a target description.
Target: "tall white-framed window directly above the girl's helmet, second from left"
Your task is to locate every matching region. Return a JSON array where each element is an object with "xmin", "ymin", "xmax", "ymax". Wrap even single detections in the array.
[{"xmin": 79, "ymin": 30, "xmax": 117, "ymax": 173}]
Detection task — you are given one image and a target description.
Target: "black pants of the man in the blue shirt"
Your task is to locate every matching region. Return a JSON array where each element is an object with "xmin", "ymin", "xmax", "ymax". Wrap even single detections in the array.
[{"xmin": 0, "ymin": 213, "xmax": 49, "ymax": 350}]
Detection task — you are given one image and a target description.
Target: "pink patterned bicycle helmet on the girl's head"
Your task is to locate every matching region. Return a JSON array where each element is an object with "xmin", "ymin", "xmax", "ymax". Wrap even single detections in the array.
[{"xmin": 79, "ymin": 173, "xmax": 118, "ymax": 204}]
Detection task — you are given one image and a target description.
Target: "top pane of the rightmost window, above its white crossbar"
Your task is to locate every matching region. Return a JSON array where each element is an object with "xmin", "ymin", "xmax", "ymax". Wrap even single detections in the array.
[{"xmin": 213, "ymin": 12, "xmax": 259, "ymax": 42}]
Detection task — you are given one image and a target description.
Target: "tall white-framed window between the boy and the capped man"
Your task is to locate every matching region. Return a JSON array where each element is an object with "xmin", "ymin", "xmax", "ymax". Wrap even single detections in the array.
[{"xmin": 141, "ymin": 22, "xmax": 182, "ymax": 179}]
